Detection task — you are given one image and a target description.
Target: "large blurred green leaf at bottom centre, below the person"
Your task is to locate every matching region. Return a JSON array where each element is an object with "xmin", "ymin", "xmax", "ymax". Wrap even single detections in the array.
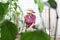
[{"xmin": 20, "ymin": 30, "xmax": 50, "ymax": 40}]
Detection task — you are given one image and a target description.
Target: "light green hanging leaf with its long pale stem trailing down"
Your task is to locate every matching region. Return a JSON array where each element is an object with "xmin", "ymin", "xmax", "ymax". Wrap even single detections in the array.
[{"xmin": 34, "ymin": 0, "xmax": 46, "ymax": 31}]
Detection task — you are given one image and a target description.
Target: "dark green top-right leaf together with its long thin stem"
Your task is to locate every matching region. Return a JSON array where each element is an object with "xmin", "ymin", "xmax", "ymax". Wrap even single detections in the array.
[{"xmin": 48, "ymin": 0, "xmax": 58, "ymax": 40}]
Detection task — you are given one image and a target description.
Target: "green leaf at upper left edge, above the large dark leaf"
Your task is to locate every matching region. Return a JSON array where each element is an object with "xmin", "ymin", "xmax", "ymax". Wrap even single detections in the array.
[{"xmin": 0, "ymin": 2, "xmax": 9, "ymax": 21}]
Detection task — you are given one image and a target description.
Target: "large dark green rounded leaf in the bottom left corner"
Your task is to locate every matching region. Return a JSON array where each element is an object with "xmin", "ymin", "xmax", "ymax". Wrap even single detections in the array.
[{"xmin": 0, "ymin": 20, "xmax": 18, "ymax": 40}]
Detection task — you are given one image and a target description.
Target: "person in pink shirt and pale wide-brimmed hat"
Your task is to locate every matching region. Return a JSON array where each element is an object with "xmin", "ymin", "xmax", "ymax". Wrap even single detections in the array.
[{"xmin": 24, "ymin": 9, "xmax": 36, "ymax": 29}]
